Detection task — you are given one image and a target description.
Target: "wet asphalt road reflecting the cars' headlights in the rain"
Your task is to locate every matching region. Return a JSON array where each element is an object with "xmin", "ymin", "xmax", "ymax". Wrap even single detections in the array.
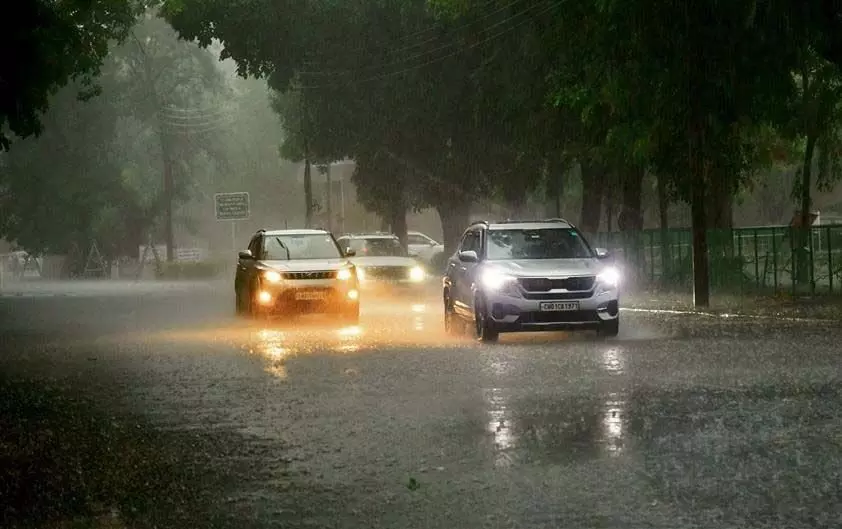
[{"xmin": 0, "ymin": 282, "xmax": 842, "ymax": 529}]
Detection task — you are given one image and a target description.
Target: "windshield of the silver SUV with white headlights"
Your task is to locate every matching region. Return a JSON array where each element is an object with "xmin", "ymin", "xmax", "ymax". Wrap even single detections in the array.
[{"xmin": 488, "ymin": 228, "xmax": 593, "ymax": 261}]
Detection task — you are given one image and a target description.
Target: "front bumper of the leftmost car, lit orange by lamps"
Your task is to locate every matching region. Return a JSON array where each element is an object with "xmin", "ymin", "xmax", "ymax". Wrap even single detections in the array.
[{"xmin": 256, "ymin": 279, "xmax": 360, "ymax": 313}]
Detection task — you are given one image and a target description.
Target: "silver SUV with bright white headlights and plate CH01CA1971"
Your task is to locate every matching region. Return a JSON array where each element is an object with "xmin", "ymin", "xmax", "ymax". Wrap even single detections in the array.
[{"xmin": 443, "ymin": 219, "xmax": 620, "ymax": 342}]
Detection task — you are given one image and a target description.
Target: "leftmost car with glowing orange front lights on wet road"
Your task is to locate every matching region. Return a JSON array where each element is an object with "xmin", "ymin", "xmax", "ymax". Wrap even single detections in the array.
[{"xmin": 234, "ymin": 230, "xmax": 360, "ymax": 324}]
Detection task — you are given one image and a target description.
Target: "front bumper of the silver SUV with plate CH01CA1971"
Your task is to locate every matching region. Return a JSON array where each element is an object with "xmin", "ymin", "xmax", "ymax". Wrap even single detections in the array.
[{"xmin": 486, "ymin": 290, "xmax": 620, "ymax": 332}]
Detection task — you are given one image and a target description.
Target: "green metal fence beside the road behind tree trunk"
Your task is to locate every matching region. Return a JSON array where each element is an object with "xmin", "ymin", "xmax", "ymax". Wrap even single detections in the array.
[{"xmin": 591, "ymin": 225, "xmax": 842, "ymax": 294}]
